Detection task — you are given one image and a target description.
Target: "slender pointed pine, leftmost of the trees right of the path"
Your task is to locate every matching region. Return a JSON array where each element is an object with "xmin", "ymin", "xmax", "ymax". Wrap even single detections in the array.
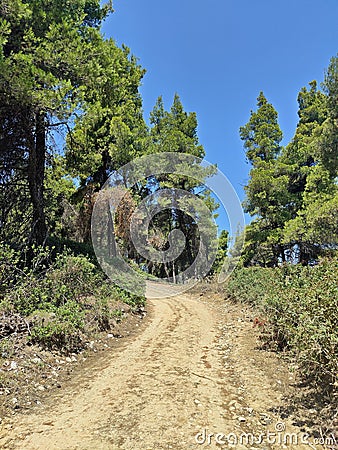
[{"xmin": 240, "ymin": 92, "xmax": 289, "ymax": 265}]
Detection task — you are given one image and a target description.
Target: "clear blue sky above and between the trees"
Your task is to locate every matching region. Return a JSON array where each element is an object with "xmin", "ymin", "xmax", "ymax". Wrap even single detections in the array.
[{"xmin": 103, "ymin": 0, "xmax": 338, "ymax": 229}]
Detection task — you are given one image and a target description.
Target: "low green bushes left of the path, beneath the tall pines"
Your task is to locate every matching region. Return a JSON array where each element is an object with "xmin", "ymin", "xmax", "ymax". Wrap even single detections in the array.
[{"xmin": 0, "ymin": 245, "xmax": 145, "ymax": 352}]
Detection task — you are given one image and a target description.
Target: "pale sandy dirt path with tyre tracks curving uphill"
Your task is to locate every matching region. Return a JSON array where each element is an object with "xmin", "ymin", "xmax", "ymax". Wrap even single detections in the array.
[{"xmin": 0, "ymin": 295, "xmax": 321, "ymax": 450}]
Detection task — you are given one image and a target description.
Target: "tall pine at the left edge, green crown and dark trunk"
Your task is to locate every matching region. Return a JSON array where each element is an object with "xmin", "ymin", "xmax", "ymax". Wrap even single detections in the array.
[{"xmin": 0, "ymin": 0, "xmax": 111, "ymax": 244}]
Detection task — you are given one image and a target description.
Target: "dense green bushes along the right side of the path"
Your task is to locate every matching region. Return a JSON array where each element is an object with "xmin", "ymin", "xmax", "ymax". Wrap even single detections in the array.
[{"xmin": 225, "ymin": 258, "xmax": 338, "ymax": 391}]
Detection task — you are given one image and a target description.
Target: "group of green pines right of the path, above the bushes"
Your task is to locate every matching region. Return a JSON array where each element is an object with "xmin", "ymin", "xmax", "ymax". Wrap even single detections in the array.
[{"xmin": 240, "ymin": 58, "xmax": 338, "ymax": 266}]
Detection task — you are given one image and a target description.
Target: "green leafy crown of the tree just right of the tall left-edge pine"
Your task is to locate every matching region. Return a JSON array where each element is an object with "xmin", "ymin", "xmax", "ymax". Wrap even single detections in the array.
[{"xmin": 66, "ymin": 40, "xmax": 146, "ymax": 188}]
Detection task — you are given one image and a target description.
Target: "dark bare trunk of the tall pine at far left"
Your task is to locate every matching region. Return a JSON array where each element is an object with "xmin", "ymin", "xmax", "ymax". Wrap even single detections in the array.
[{"xmin": 28, "ymin": 112, "xmax": 47, "ymax": 245}]
